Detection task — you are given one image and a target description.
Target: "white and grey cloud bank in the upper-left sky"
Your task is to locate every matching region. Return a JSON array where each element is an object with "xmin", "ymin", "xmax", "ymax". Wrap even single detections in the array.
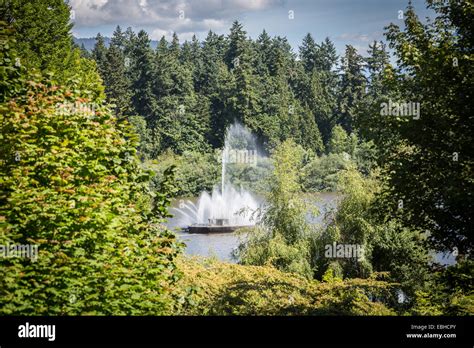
[{"xmin": 70, "ymin": 0, "xmax": 284, "ymax": 39}]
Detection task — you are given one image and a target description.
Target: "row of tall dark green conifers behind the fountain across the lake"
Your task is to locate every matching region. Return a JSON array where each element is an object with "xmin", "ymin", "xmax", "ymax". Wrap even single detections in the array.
[{"xmin": 87, "ymin": 21, "xmax": 388, "ymax": 157}]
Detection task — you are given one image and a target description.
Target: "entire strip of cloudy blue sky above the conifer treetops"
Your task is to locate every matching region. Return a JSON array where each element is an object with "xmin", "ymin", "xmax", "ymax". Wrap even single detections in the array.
[{"xmin": 69, "ymin": 0, "xmax": 431, "ymax": 54}]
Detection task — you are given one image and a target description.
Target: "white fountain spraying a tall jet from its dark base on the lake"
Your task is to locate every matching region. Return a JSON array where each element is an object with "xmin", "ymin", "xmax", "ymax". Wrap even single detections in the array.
[{"xmin": 176, "ymin": 123, "xmax": 258, "ymax": 233}]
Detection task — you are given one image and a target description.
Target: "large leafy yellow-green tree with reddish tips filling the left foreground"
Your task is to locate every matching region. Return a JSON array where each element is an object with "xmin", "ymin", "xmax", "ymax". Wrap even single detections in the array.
[{"xmin": 0, "ymin": 32, "xmax": 180, "ymax": 315}]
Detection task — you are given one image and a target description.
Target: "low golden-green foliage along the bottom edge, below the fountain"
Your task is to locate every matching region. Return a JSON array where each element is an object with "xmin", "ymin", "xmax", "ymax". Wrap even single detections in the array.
[{"xmin": 174, "ymin": 258, "xmax": 395, "ymax": 316}]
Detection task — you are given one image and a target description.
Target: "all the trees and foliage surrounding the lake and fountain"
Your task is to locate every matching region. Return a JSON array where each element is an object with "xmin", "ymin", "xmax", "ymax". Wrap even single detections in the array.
[{"xmin": 0, "ymin": 0, "xmax": 474, "ymax": 315}]
